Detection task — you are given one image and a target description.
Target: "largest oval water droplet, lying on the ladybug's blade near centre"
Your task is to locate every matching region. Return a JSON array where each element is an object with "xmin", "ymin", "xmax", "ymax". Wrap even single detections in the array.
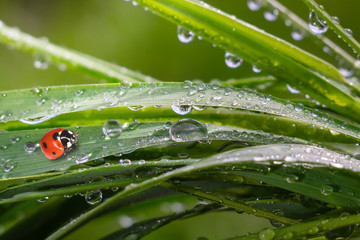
[{"xmin": 169, "ymin": 119, "xmax": 208, "ymax": 142}]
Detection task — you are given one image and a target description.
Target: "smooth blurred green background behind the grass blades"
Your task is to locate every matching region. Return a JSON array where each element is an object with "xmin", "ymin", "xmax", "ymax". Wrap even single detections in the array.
[{"xmin": 0, "ymin": 0, "xmax": 360, "ymax": 240}]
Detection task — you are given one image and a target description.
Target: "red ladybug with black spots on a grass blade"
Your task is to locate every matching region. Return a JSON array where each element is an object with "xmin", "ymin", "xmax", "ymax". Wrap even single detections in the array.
[{"xmin": 40, "ymin": 128, "xmax": 78, "ymax": 159}]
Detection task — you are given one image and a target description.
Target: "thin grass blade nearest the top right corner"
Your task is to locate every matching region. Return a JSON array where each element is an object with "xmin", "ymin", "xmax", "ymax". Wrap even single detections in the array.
[{"xmin": 303, "ymin": 0, "xmax": 360, "ymax": 57}]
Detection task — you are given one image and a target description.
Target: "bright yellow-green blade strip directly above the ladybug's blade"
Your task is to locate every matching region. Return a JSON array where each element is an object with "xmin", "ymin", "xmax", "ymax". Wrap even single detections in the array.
[{"xmin": 0, "ymin": 105, "xmax": 356, "ymax": 146}]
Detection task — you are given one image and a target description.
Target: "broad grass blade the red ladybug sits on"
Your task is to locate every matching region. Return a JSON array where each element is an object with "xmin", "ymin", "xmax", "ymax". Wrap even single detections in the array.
[{"xmin": 0, "ymin": 122, "xmax": 306, "ymax": 180}]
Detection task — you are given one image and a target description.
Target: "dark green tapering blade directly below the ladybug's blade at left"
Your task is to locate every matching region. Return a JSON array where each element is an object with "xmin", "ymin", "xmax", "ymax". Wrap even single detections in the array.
[{"xmin": 0, "ymin": 159, "xmax": 198, "ymax": 204}]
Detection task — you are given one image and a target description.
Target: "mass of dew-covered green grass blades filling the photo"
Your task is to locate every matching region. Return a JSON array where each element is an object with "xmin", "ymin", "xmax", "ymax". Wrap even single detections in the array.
[{"xmin": 0, "ymin": 0, "xmax": 360, "ymax": 240}]
